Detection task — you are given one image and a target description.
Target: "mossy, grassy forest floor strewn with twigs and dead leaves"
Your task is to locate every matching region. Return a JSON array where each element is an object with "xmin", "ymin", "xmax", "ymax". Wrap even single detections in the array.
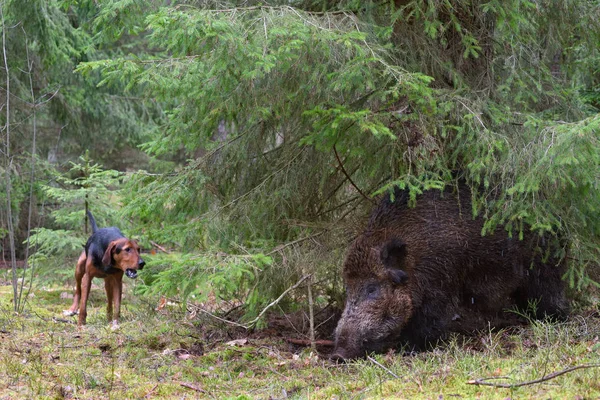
[{"xmin": 0, "ymin": 271, "xmax": 600, "ymax": 399}]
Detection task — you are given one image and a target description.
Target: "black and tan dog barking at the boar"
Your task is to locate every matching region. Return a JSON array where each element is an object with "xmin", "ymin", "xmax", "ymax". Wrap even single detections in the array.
[{"xmin": 64, "ymin": 211, "xmax": 146, "ymax": 328}]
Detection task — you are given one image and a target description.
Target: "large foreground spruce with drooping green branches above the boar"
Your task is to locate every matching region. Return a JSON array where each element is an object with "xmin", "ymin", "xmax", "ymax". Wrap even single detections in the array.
[{"xmin": 64, "ymin": 0, "xmax": 600, "ymax": 312}]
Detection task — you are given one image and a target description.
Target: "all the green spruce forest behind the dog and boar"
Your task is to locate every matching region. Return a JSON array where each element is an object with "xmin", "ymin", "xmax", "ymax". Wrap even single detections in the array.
[{"xmin": 0, "ymin": 0, "xmax": 600, "ymax": 322}]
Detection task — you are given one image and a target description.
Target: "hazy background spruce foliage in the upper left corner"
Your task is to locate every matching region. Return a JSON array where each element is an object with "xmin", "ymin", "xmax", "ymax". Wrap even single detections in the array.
[{"xmin": 0, "ymin": 0, "xmax": 156, "ymax": 168}]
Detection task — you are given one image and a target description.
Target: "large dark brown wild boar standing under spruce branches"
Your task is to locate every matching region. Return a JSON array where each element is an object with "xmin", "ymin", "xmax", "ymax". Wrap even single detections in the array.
[{"xmin": 332, "ymin": 184, "xmax": 568, "ymax": 360}]
